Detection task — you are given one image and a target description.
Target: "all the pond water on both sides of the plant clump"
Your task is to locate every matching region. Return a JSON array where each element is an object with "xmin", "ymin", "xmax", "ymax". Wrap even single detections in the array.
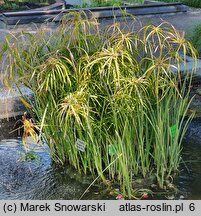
[{"xmin": 0, "ymin": 120, "xmax": 201, "ymax": 200}]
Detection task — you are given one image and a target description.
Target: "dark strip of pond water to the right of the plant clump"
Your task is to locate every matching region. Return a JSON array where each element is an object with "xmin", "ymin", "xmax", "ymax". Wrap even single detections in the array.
[{"xmin": 175, "ymin": 118, "xmax": 201, "ymax": 200}]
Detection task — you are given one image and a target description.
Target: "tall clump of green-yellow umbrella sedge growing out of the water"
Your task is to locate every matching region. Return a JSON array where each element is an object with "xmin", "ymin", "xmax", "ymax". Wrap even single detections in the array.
[{"xmin": 1, "ymin": 12, "xmax": 195, "ymax": 198}]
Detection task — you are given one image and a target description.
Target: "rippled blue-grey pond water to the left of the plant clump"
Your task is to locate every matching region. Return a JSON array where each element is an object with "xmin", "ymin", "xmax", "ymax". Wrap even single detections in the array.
[{"xmin": 0, "ymin": 138, "xmax": 113, "ymax": 200}]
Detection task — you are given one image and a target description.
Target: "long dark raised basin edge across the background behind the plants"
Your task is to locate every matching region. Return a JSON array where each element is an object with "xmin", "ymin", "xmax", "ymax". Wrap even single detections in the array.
[{"xmin": 1, "ymin": 0, "xmax": 188, "ymax": 25}]
